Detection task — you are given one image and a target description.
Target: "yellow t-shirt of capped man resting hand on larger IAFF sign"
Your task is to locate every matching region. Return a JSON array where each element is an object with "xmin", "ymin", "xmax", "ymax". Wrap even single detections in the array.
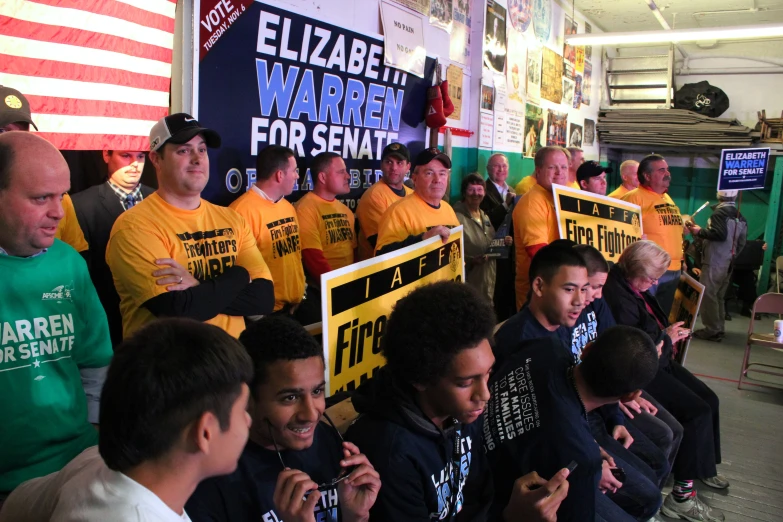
[{"xmin": 375, "ymin": 192, "xmax": 459, "ymax": 252}]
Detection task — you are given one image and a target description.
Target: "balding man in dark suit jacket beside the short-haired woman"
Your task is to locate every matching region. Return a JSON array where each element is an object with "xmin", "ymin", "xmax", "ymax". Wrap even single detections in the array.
[{"xmin": 481, "ymin": 154, "xmax": 516, "ymax": 321}]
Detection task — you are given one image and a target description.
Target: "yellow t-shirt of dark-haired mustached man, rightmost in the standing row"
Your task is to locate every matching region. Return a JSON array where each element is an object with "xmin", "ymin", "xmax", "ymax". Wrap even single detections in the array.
[{"xmin": 621, "ymin": 186, "xmax": 683, "ymax": 270}]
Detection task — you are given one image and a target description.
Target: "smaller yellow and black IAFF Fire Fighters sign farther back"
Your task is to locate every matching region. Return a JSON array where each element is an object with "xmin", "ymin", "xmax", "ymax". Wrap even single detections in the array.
[{"xmin": 552, "ymin": 185, "xmax": 644, "ymax": 261}]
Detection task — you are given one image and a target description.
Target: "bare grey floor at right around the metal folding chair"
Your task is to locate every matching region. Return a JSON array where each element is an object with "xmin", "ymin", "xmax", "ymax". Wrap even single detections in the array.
[{"xmin": 666, "ymin": 313, "xmax": 783, "ymax": 522}]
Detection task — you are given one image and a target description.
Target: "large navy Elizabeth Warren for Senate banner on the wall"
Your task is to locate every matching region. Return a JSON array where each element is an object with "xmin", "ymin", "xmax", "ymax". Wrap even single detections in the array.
[{"xmin": 196, "ymin": 2, "xmax": 435, "ymax": 210}]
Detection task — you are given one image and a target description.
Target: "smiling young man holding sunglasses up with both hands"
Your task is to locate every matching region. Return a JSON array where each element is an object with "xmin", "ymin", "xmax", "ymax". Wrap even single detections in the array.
[{"xmin": 187, "ymin": 316, "xmax": 381, "ymax": 522}]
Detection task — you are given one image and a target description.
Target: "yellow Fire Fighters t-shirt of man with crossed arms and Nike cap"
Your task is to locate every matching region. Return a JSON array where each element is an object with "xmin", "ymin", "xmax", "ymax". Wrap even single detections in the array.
[{"xmin": 106, "ymin": 192, "xmax": 272, "ymax": 337}]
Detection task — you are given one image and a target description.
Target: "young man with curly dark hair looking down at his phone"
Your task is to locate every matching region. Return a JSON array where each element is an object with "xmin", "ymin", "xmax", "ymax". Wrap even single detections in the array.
[{"xmin": 346, "ymin": 281, "xmax": 568, "ymax": 522}]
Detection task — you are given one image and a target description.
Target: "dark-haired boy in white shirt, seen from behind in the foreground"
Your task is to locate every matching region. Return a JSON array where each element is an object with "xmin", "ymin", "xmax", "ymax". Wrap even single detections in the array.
[{"xmin": 0, "ymin": 319, "xmax": 253, "ymax": 522}]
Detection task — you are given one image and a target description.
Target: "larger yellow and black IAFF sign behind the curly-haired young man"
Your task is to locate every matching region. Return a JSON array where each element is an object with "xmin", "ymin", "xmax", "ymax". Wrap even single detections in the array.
[{"xmin": 321, "ymin": 226, "xmax": 465, "ymax": 396}]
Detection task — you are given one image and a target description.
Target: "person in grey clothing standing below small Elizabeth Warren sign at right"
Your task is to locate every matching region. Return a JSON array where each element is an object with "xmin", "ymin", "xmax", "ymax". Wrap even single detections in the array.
[{"xmin": 688, "ymin": 190, "xmax": 748, "ymax": 342}]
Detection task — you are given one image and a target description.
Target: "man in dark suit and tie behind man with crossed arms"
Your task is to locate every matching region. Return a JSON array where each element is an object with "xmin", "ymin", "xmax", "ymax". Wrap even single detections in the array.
[{"xmin": 73, "ymin": 150, "xmax": 155, "ymax": 346}]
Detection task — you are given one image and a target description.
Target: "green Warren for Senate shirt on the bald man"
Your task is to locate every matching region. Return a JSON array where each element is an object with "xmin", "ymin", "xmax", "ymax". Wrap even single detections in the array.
[{"xmin": 0, "ymin": 240, "xmax": 112, "ymax": 494}]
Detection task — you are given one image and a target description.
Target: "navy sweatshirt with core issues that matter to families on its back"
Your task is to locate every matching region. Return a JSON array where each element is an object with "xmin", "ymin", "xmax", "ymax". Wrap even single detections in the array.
[{"xmin": 484, "ymin": 336, "xmax": 601, "ymax": 522}]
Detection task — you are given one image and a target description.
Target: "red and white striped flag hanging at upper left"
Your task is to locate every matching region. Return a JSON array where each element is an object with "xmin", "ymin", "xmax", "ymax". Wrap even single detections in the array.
[{"xmin": 0, "ymin": 0, "xmax": 176, "ymax": 150}]
